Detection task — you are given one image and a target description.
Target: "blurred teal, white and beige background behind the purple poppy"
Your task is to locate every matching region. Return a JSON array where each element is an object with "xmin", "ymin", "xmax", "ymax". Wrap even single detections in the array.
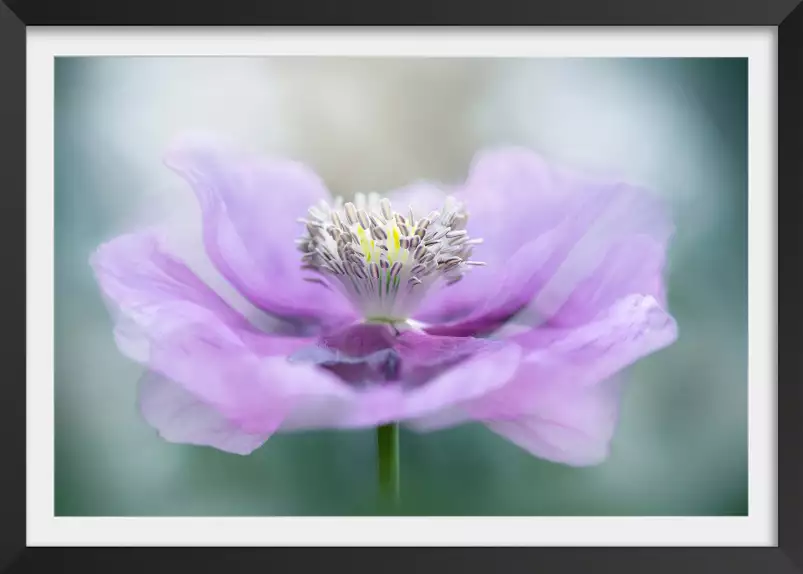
[{"xmin": 55, "ymin": 58, "xmax": 747, "ymax": 516}]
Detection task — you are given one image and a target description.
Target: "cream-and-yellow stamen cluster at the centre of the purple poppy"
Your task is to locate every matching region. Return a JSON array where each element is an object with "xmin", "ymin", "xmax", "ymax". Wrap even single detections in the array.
[{"xmin": 296, "ymin": 193, "xmax": 484, "ymax": 323}]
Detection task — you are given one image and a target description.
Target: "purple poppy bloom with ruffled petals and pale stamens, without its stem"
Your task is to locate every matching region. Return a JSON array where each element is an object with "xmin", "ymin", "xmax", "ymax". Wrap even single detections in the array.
[{"xmin": 92, "ymin": 138, "xmax": 677, "ymax": 465}]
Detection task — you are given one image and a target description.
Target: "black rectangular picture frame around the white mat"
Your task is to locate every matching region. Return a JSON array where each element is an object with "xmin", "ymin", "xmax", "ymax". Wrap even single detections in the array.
[{"xmin": 0, "ymin": 0, "xmax": 792, "ymax": 574}]
